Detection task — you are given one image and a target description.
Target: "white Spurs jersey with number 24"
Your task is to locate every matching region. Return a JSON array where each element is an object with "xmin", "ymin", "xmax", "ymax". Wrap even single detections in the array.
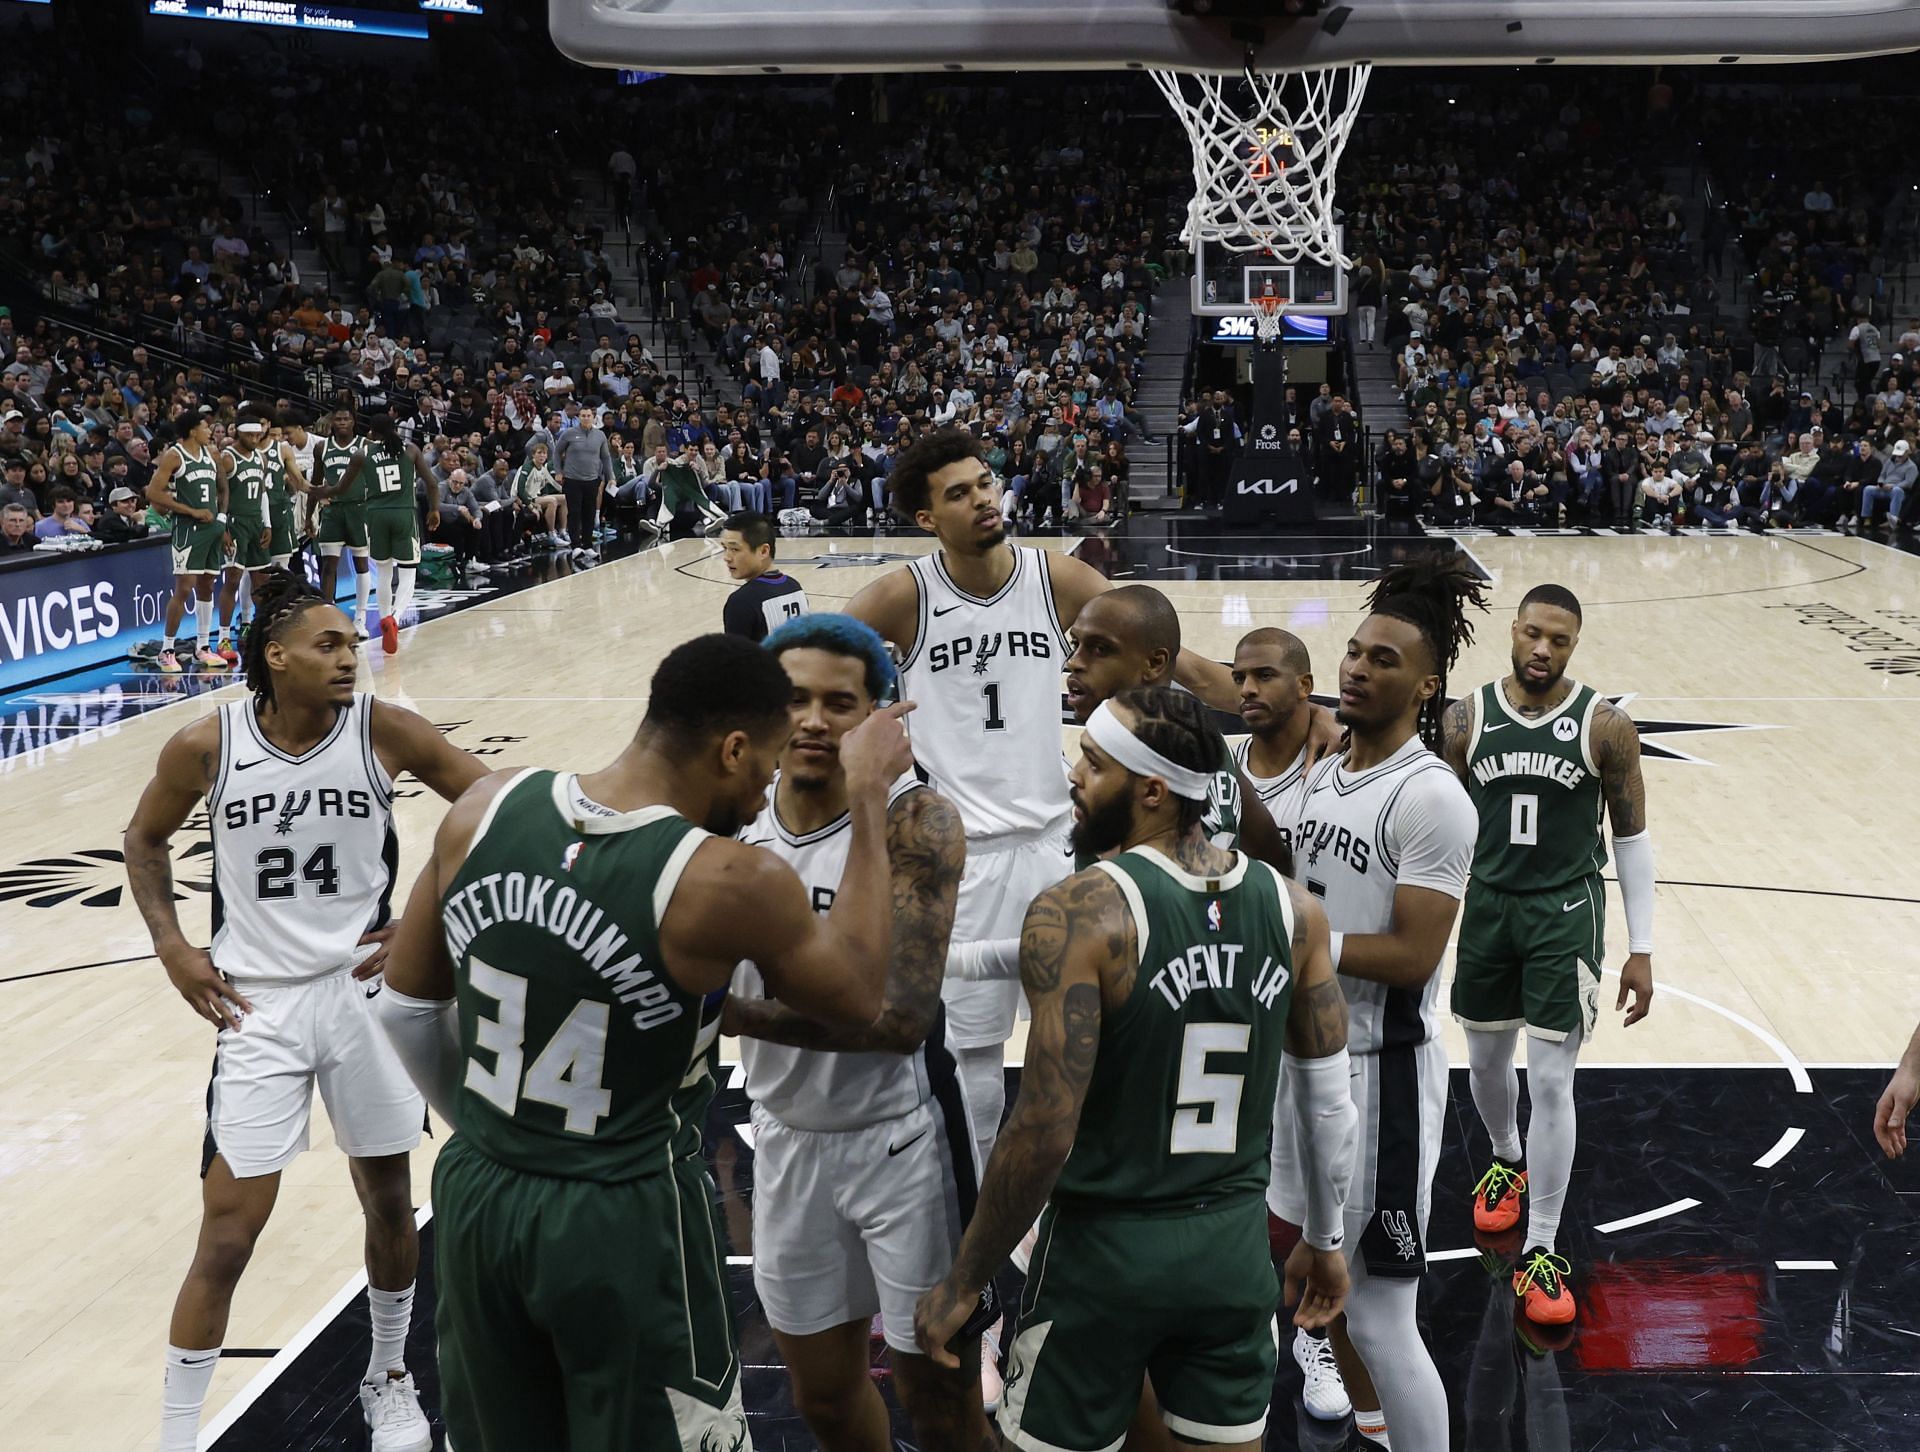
[{"xmin": 207, "ymin": 693, "xmax": 399, "ymax": 983}]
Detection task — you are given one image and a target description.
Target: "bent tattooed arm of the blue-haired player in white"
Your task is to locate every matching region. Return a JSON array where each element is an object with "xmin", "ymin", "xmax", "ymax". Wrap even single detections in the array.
[{"xmin": 721, "ymin": 791, "xmax": 966, "ymax": 1054}]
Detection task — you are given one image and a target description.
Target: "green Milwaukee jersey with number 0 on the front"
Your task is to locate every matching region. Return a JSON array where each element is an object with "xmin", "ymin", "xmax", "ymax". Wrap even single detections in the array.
[{"xmin": 1467, "ymin": 680, "xmax": 1607, "ymax": 893}]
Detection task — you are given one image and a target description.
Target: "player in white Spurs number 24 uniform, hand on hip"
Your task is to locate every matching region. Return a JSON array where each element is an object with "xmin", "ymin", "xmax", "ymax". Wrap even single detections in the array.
[{"xmin": 127, "ymin": 570, "xmax": 488, "ymax": 1452}]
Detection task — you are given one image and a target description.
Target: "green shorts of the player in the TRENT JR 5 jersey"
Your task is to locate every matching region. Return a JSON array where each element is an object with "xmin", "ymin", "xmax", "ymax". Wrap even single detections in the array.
[{"xmin": 1000, "ymin": 1195, "xmax": 1281, "ymax": 1452}]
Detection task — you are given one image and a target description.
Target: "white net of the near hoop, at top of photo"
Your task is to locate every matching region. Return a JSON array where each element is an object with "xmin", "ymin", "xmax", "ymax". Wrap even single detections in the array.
[{"xmin": 1154, "ymin": 63, "xmax": 1373, "ymax": 269}]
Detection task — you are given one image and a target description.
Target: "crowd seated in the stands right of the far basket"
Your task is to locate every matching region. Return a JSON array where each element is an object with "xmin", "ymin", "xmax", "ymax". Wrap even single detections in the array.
[{"xmin": 1340, "ymin": 81, "xmax": 1920, "ymax": 530}]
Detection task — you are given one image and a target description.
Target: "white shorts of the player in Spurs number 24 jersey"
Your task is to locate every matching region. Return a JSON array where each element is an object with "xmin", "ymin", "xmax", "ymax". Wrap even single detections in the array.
[{"xmin": 200, "ymin": 968, "xmax": 426, "ymax": 1179}]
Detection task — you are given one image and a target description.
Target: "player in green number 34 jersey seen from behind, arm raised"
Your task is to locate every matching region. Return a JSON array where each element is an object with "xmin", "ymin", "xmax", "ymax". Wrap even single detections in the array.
[{"xmin": 376, "ymin": 636, "xmax": 912, "ymax": 1452}]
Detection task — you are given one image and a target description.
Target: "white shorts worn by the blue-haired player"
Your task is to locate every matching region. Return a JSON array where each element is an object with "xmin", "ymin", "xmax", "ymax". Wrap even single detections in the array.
[{"xmin": 753, "ymin": 1085, "xmax": 979, "ymax": 1356}]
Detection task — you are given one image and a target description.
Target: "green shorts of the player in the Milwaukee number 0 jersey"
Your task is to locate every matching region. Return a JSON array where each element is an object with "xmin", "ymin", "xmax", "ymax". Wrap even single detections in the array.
[{"xmin": 1453, "ymin": 872, "xmax": 1607, "ymax": 1043}]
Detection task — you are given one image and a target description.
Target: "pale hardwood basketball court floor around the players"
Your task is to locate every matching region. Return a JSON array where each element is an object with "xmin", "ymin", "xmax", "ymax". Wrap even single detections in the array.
[{"xmin": 0, "ymin": 520, "xmax": 1920, "ymax": 1452}]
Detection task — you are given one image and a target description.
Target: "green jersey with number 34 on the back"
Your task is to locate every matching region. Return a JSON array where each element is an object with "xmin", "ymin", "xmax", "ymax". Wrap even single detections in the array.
[{"xmin": 440, "ymin": 770, "xmax": 724, "ymax": 1181}]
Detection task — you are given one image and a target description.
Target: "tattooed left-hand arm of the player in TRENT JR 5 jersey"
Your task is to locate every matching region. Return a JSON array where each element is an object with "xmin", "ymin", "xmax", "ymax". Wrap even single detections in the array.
[{"xmin": 954, "ymin": 872, "xmax": 1135, "ymax": 1287}]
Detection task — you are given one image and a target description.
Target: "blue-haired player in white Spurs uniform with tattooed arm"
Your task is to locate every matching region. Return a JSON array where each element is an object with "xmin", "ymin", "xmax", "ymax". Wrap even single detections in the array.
[{"xmin": 722, "ymin": 615, "xmax": 989, "ymax": 1452}]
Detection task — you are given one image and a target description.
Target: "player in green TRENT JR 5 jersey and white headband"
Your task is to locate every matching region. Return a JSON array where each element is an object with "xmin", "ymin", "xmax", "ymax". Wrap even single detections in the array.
[{"xmin": 916, "ymin": 688, "xmax": 1354, "ymax": 1452}]
